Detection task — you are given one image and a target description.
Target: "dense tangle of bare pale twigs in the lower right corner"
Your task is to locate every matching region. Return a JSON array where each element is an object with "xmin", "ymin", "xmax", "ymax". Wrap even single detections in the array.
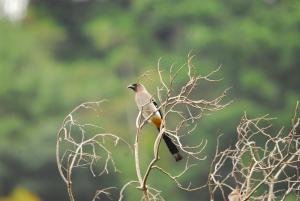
[{"xmin": 209, "ymin": 103, "xmax": 300, "ymax": 201}]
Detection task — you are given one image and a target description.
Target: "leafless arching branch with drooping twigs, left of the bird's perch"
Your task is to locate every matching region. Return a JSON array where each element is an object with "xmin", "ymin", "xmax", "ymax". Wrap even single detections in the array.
[{"xmin": 56, "ymin": 101, "xmax": 131, "ymax": 201}]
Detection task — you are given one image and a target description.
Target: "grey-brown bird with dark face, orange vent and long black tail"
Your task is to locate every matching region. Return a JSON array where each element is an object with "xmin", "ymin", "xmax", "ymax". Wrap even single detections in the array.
[{"xmin": 128, "ymin": 83, "xmax": 183, "ymax": 161}]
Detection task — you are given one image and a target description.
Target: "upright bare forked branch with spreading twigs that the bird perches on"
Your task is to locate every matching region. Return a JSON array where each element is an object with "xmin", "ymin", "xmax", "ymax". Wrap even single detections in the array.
[{"xmin": 134, "ymin": 56, "xmax": 231, "ymax": 201}]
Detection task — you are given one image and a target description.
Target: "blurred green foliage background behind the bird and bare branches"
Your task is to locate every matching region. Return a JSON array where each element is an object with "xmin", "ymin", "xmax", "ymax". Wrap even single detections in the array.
[{"xmin": 0, "ymin": 0, "xmax": 300, "ymax": 201}]
